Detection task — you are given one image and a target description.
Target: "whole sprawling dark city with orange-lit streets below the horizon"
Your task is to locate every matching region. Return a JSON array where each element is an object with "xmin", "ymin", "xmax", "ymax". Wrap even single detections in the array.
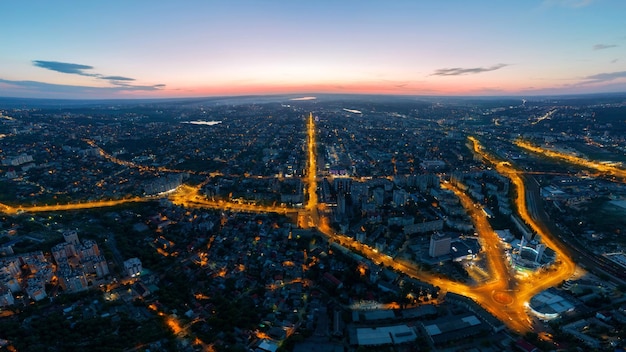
[{"xmin": 0, "ymin": 93, "xmax": 626, "ymax": 352}]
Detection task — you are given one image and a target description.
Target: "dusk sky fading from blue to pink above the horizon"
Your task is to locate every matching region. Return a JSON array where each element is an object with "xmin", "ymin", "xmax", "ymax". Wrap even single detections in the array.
[{"xmin": 0, "ymin": 0, "xmax": 626, "ymax": 99}]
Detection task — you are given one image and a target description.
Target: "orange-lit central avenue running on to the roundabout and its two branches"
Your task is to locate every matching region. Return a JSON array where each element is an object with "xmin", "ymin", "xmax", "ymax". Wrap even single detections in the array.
[{"xmin": 298, "ymin": 126, "xmax": 576, "ymax": 333}]
